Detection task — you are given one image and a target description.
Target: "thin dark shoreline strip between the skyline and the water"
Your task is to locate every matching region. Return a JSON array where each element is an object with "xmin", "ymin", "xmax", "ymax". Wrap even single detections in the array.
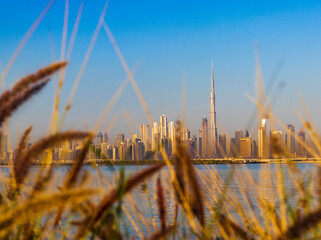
[{"xmin": 0, "ymin": 158, "xmax": 321, "ymax": 166}]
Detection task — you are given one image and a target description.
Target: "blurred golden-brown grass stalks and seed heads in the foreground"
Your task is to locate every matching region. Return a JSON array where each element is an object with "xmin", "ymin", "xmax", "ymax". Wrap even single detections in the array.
[{"xmin": 0, "ymin": 4, "xmax": 321, "ymax": 239}]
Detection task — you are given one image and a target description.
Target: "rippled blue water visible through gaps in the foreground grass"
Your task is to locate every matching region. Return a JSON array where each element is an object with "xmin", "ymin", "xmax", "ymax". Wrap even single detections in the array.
[{"xmin": 1, "ymin": 163, "xmax": 315, "ymax": 237}]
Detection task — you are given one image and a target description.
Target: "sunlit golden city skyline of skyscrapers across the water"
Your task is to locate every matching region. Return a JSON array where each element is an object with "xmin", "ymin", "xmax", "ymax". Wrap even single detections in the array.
[{"xmin": 0, "ymin": 63, "xmax": 311, "ymax": 161}]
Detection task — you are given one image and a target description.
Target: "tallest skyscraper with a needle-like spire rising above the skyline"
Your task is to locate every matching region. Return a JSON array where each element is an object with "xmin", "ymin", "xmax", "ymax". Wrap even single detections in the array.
[{"xmin": 208, "ymin": 59, "xmax": 217, "ymax": 157}]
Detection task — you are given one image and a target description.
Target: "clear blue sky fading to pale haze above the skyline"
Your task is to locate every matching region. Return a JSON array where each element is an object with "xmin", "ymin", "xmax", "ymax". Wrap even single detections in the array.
[{"xmin": 0, "ymin": 0, "xmax": 321, "ymax": 145}]
